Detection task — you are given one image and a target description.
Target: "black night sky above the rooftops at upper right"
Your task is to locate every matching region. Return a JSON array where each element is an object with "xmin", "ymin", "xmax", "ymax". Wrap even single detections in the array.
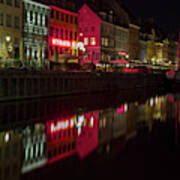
[{"xmin": 123, "ymin": 0, "xmax": 180, "ymax": 32}]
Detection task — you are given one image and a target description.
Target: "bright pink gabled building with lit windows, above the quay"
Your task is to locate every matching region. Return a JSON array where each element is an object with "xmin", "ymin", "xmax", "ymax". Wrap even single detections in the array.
[{"xmin": 78, "ymin": 4, "xmax": 101, "ymax": 64}]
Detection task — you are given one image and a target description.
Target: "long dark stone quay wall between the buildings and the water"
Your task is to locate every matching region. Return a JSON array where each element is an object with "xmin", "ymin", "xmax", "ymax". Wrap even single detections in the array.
[{"xmin": 0, "ymin": 70, "xmax": 165, "ymax": 101}]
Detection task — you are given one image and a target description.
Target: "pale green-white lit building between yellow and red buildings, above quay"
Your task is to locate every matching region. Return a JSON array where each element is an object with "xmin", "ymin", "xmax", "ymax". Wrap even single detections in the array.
[{"xmin": 23, "ymin": 0, "xmax": 50, "ymax": 64}]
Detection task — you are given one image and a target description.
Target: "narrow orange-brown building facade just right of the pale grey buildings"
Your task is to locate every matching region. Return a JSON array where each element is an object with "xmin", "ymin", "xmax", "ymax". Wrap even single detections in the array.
[{"xmin": 128, "ymin": 24, "xmax": 140, "ymax": 59}]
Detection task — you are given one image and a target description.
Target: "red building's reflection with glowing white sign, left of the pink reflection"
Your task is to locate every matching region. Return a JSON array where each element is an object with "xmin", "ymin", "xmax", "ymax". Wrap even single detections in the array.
[{"xmin": 46, "ymin": 116, "xmax": 76, "ymax": 163}]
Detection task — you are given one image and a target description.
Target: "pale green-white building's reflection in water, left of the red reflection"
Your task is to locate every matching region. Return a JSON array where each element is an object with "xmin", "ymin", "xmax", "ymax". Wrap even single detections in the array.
[{"xmin": 21, "ymin": 124, "xmax": 47, "ymax": 173}]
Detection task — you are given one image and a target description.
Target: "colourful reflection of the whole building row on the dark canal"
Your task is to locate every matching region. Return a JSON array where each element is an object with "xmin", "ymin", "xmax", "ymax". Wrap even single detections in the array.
[{"xmin": 0, "ymin": 91, "xmax": 180, "ymax": 180}]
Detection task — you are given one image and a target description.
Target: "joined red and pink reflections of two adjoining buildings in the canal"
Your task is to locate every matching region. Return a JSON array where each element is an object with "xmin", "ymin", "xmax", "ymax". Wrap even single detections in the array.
[{"xmin": 46, "ymin": 111, "xmax": 99, "ymax": 163}]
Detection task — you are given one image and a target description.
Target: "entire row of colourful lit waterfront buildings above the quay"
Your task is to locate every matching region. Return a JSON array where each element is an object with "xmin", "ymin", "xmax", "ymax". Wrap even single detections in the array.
[{"xmin": 0, "ymin": 0, "xmax": 178, "ymax": 67}]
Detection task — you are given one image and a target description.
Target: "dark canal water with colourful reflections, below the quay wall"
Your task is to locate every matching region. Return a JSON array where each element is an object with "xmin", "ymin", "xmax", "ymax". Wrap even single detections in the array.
[{"xmin": 0, "ymin": 91, "xmax": 180, "ymax": 180}]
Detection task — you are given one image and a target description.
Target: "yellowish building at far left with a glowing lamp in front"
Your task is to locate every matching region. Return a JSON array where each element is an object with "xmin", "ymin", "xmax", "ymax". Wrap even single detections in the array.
[{"xmin": 0, "ymin": 0, "xmax": 23, "ymax": 62}]
